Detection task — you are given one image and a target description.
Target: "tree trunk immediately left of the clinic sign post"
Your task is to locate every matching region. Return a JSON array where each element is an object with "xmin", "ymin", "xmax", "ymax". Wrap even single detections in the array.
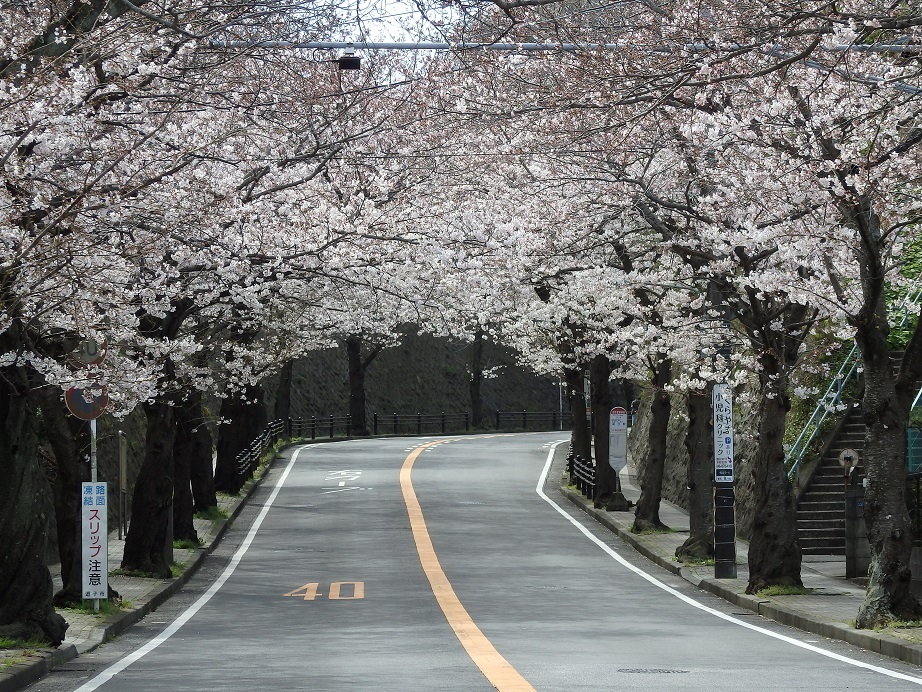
[{"xmin": 676, "ymin": 388, "xmax": 714, "ymax": 562}]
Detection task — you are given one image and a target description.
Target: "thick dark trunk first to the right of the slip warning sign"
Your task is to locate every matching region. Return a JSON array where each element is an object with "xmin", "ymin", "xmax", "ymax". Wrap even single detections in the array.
[{"xmin": 122, "ymin": 400, "xmax": 176, "ymax": 579}]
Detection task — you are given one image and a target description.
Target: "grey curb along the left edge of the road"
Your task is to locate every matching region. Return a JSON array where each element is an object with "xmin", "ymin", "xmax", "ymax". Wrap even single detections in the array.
[{"xmin": 0, "ymin": 445, "xmax": 278, "ymax": 692}]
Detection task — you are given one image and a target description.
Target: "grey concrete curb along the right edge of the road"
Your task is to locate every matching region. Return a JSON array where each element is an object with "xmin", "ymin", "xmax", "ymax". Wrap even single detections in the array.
[{"xmin": 560, "ymin": 484, "xmax": 922, "ymax": 666}]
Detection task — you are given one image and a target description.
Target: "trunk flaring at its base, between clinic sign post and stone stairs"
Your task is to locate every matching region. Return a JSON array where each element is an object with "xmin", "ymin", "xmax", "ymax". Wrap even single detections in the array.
[{"xmin": 746, "ymin": 360, "xmax": 803, "ymax": 594}]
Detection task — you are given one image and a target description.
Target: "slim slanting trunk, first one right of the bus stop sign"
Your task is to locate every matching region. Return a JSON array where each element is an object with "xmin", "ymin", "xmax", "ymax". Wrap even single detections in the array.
[{"xmin": 631, "ymin": 358, "xmax": 672, "ymax": 533}]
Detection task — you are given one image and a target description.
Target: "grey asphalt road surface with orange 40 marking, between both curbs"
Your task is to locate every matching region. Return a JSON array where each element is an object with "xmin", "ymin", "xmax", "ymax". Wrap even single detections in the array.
[{"xmin": 29, "ymin": 433, "xmax": 922, "ymax": 692}]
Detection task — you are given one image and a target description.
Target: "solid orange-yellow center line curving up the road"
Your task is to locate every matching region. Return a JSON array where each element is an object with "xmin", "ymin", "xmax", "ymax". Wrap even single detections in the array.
[{"xmin": 400, "ymin": 440, "xmax": 535, "ymax": 692}]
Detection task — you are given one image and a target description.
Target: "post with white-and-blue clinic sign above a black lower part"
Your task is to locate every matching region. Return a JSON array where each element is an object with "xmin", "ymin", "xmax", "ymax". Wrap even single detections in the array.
[{"xmin": 711, "ymin": 384, "xmax": 736, "ymax": 579}]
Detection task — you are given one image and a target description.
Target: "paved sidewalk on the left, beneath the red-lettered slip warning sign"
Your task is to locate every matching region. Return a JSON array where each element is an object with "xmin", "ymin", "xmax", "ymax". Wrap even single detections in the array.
[{"xmin": 0, "ymin": 464, "xmax": 272, "ymax": 692}]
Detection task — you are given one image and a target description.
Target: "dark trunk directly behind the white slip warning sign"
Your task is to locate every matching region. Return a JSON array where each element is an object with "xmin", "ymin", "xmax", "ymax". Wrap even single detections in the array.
[{"xmin": 38, "ymin": 386, "xmax": 90, "ymax": 606}]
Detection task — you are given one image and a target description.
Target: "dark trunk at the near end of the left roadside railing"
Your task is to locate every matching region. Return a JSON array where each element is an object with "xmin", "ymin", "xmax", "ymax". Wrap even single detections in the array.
[{"xmin": 215, "ymin": 384, "xmax": 268, "ymax": 495}]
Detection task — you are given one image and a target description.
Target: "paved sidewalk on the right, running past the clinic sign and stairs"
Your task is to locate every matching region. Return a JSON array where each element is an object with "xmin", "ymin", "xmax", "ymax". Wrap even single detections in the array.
[{"xmin": 561, "ymin": 462, "xmax": 922, "ymax": 666}]
